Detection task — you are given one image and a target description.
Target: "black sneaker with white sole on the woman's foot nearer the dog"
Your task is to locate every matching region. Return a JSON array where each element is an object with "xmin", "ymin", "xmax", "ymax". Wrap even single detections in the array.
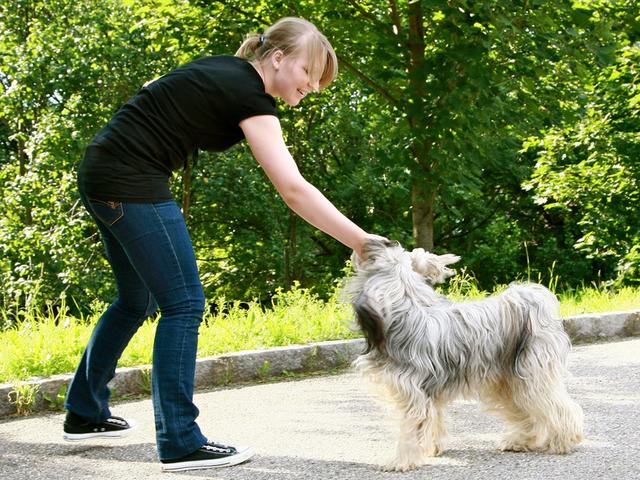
[{"xmin": 162, "ymin": 442, "xmax": 253, "ymax": 472}]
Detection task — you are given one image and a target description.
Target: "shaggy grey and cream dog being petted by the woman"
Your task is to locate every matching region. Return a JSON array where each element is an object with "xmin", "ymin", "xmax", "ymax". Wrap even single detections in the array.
[{"xmin": 346, "ymin": 241, "xmax": 583, "ymax": 471}]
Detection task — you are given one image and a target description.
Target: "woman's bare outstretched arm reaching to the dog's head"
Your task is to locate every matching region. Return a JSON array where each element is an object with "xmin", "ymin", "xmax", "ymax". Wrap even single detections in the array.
[{"xmin": 240, "ymin": 115, "xmax": 381, "ymax": 255}]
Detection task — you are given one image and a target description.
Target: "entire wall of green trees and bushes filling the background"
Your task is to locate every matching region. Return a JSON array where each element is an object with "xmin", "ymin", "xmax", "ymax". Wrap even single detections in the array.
[{"xmin": 0, "ymin": 0, "xmax": 640, "ymax": 316}]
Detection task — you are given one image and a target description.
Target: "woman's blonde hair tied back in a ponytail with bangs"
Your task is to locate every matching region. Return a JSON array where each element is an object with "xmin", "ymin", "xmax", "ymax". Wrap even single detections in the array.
[{"xmin": 236, "ymin": 17, "xmax": 338, "ymax": 88}]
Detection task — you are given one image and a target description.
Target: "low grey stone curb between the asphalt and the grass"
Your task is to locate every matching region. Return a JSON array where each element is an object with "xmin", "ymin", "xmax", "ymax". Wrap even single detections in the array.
[{"xmin": 0, "ymin": 310, "xmax": 640, "ymax": 418}]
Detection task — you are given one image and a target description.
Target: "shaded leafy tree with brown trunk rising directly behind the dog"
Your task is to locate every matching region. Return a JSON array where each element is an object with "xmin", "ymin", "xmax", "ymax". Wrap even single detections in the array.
[{"xmin": 268, "ymin": 0, "xmax": 616, "ymax": 255}]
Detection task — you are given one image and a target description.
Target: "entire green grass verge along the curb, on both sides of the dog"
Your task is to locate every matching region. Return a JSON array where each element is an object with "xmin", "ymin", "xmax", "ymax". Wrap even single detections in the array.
[{"xmin": 0, "ymin": 275, "xmax": 640, "ymax": 382}]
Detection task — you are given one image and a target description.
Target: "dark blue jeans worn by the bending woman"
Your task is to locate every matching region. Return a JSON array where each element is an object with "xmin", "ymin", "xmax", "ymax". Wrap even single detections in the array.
[{"xmin": 65, "ymin": 194, "xmax": 207, "ymax": 460}]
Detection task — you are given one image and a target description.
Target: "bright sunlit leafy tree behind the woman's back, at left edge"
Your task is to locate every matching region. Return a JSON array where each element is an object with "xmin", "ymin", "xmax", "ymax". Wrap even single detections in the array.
[{"xmin": 0, "ymin": 0, "xmax": 202, "ymax": 312}]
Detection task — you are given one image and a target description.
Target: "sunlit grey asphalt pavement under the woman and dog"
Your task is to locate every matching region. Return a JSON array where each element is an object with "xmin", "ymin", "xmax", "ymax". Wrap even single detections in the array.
[{"xmin": 0, "ymin": 338, "xmax": 640, "ymax": 480}]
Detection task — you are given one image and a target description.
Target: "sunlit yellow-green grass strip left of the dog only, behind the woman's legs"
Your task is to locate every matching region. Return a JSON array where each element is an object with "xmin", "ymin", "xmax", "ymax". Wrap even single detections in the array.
[{"xmin": 0, "ymin": 284, "xmax": 356, "ymax": 388}]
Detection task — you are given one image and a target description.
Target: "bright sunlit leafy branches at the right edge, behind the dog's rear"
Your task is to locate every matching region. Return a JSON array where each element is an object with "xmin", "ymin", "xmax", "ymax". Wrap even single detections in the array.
[{"xmin": 525, "ymin": 40, "xmax": 640, "ymax": 284}]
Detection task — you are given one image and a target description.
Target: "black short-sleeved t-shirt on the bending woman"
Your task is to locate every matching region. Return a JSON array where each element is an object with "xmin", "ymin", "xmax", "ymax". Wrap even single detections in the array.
[{"xmin": 78, "ymin": 55, "xmax": 277, "ymax": 202}]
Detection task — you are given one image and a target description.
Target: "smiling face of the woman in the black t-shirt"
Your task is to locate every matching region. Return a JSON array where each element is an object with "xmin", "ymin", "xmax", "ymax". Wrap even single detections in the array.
[{"xmin": 272, "ymin": 54, "xmax": 320, "ymax": 107}]
